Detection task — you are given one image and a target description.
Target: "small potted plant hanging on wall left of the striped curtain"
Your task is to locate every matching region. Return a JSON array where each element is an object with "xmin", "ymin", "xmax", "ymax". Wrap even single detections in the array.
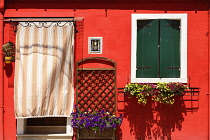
[{"xmin": 2, "ymin": 42, "xmax": 15, "ymax": 64}]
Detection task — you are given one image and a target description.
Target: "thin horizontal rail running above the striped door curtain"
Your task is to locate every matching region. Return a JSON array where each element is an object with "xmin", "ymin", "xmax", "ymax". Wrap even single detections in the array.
[{"xmin": 4, "ymin": 17, "xmax": 84, "ymax": 22}]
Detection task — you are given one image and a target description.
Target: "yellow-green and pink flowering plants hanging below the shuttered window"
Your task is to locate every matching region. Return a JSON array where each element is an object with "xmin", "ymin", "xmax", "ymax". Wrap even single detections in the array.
[{"xmin": 124, "ymin": 82, "xmax": 187, "ymax": 104}]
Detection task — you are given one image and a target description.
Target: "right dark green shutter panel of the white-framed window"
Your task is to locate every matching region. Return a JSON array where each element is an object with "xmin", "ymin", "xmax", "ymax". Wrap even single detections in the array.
[{"xmin": 160, "ymin": 19, "xmax": 180, "ymax": 78}]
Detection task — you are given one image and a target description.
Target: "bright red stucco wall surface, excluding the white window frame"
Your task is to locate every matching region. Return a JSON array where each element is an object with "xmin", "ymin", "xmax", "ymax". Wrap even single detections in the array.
[{"xmin": 4, "ymin": 2, "xmax": 210, "ymax": 140}]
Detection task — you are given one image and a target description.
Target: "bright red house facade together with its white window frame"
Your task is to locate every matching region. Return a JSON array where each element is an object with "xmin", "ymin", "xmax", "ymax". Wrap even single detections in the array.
[{"xmin": 0, "ymin": 0, "xmax": 210, "ymax": 140}]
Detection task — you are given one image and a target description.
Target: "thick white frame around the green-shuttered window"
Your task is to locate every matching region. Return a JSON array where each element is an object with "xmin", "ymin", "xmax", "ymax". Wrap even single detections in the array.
[{"xmin": 131, "ymin": 14, "xmax": 187, "ymax": 83}]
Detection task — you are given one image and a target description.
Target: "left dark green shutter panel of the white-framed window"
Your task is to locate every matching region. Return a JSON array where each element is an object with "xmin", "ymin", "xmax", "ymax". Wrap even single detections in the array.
[{"xmin": 136, "ymin": 20, "xmax": 158, "ymax": 78}]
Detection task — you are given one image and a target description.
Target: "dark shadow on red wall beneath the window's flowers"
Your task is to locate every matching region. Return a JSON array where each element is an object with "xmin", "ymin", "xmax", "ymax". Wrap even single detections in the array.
[{"xmin": 124, "ymin": 97, "xmax": 186, "ymax": 140}]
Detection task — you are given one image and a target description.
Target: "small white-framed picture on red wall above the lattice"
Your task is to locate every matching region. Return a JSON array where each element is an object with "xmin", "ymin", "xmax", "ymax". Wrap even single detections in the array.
[{"xmin": 88, "ymin": 37, "xmax": 102, "ymax": 54}]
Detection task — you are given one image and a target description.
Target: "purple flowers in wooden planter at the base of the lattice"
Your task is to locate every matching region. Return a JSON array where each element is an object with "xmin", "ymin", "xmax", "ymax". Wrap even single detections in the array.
[{"xmin": 71, "ymin": 107, "xmax": 122, "ymax": 137}]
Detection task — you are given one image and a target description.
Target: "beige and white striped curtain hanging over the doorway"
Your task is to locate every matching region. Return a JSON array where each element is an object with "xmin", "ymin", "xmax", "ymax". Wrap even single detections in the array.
[{"xmin": 14, "ymin": 22, "xmax": 74, "ymax": 118}]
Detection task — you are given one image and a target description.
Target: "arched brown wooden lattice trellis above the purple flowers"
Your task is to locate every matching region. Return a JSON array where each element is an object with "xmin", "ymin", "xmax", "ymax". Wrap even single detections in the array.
[{"xmin": 76, "ymin": 57, "xmax": 116, "ymax": 114}]
